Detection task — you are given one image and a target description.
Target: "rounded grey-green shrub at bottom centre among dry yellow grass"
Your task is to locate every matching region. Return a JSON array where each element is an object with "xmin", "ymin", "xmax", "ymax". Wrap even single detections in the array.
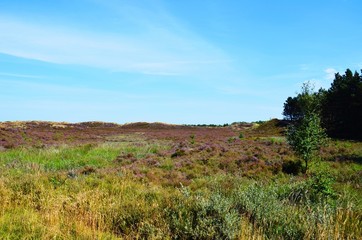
[{"xmin": 165, "ymin": 188, "xmax": 240, "ymax": 239}]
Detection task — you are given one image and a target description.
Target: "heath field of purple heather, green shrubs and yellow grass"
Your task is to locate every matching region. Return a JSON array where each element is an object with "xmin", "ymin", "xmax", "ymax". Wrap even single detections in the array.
[{"xmin": 0, "ymin": 119, "xmax": 362, "ymax": 239}]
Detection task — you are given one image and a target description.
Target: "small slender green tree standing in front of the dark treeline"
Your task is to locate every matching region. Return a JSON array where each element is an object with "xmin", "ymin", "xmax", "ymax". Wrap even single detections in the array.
[{"xmin": 287, "ymin": 84, "xmax": 327, "ymax": 172}]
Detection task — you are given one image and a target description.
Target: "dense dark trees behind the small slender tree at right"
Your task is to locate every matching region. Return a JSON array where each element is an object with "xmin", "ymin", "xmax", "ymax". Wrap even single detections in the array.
[{"xmin": 283, "ymin": 69, "xmax": 362, "ymax": 140}]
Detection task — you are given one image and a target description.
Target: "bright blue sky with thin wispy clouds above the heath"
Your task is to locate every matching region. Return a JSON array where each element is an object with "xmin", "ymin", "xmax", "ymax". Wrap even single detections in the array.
[{"xmin": 0, "ymin": 0, "xmax": 362, "ymax": 124}]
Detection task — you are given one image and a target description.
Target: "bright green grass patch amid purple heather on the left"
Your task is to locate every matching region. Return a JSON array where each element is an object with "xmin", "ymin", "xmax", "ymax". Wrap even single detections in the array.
[{"xmin": 0, "ymin": 143, "xmax": 170, "ymax": 171}]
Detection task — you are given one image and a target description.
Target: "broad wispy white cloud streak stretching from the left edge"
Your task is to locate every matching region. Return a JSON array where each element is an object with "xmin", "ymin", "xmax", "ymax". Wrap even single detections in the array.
[{"xmin": 0, "ymin": 1, "xmax": 230, "ymax": 75}]
